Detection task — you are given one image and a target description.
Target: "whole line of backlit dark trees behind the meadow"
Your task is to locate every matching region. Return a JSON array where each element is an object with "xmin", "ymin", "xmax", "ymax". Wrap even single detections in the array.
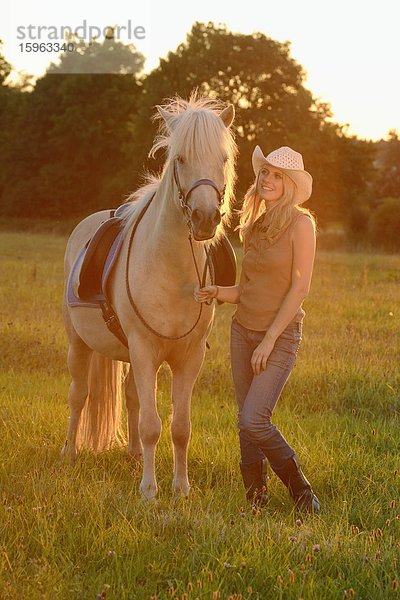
[{"xmin": 0, "ymin": 23, "xmax": 400, "ymax": 248}]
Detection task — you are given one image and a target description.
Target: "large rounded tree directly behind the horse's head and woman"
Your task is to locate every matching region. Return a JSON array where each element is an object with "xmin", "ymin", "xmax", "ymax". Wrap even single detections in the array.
[{"xmin": 127, "ymin": 23, "xmax": 376, "ymax": 226}]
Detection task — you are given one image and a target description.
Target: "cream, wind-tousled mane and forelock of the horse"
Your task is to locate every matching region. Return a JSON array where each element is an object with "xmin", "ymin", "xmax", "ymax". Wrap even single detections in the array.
[{"xmin": 124, "ymin": 92, "xmax": 237, "ymax": 241}]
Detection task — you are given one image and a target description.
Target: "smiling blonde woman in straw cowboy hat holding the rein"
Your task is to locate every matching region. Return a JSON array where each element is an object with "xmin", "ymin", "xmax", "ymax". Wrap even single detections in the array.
[{"xmin": 194, "ymin": 146, "xmax": 320, "ymax": 512}]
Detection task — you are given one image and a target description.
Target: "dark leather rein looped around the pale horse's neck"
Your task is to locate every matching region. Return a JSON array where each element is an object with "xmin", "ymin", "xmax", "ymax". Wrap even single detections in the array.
[{"xmin": 125, "ymin": 157, "xmax": 225, "ymax": 340}]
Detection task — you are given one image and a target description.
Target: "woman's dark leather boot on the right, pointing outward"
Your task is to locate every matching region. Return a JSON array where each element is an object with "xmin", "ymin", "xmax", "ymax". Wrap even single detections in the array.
[{"xmin": 275, "ymin": 456, "xmax": 321, "ymax": 513}]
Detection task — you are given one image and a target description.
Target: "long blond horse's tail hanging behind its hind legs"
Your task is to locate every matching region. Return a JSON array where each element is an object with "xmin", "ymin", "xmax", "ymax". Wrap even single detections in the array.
[{"xmin": 77, "ymin": 352, "xmax": 126, "ymax": 452}]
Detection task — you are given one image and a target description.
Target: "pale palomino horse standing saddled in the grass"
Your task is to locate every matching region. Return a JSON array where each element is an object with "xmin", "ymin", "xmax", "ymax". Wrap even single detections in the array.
[{"xmin": 63, "ymin": 97, "xmax": 236, "ymax": 499}]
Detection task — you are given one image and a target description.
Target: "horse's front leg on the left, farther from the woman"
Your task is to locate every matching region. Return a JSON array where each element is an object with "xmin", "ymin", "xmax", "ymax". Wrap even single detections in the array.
[{"xmin": 131, "ymin": 354, "xmax": 161, "ymax": 500}]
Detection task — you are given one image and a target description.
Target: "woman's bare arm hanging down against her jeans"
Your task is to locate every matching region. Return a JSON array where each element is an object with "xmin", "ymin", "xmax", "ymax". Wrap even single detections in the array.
[{"xmin": 251, "ymin": 217, "xmax": 315, "ymax": 375}]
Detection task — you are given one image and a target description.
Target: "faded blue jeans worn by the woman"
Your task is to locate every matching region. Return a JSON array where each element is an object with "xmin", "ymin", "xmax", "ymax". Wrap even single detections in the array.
[{"xmin": 231, "ymin": 319, "xmax": 302, "ymax": 473}]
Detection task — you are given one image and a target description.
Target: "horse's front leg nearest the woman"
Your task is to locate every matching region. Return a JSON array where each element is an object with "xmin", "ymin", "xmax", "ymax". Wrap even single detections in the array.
[{"xmin": 171, "ymin": 348, "xmax": 204, "ymax": 498}]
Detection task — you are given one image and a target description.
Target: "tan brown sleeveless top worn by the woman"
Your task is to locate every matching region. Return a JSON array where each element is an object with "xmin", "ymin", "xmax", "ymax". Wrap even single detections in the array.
[{"xmin": 234, "ymin": 209, "xmax": 310, "ymax": 331}]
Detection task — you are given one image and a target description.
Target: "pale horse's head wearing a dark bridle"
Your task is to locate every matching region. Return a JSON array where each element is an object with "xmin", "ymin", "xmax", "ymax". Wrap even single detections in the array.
[{"xmin": 155, "ymin": 98, "xmax": 236, "ymax": 241}]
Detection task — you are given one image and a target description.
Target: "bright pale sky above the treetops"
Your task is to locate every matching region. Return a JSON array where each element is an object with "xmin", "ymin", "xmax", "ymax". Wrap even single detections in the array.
[{"xmin": 0, "ymin": 0, "xmax": 400, "ymax": 139}]
